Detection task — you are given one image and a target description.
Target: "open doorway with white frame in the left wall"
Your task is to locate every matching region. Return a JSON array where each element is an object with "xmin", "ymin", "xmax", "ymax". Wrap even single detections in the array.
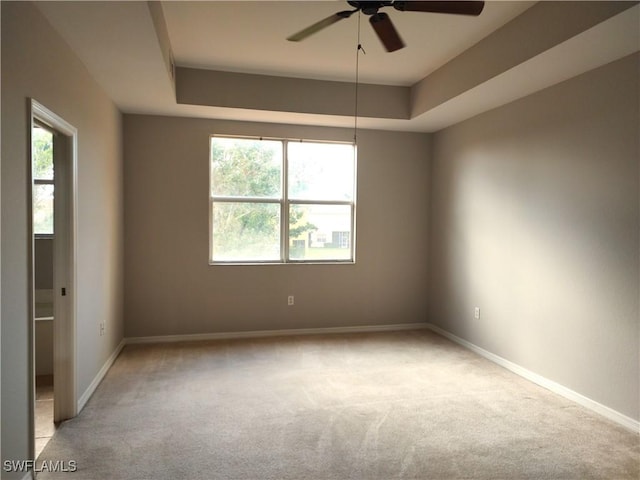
[{"xmin": 29, "ymin": 100, "xmax": 77, "ymax": 459}]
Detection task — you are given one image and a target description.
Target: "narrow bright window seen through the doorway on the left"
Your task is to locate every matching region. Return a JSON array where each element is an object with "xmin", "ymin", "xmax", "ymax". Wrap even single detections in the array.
[{"xmin": 31, "ymin": 125, "xmax": 53, "ymax": 235}]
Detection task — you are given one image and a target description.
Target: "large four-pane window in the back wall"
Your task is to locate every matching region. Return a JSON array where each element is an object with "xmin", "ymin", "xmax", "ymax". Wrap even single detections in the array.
[{"xmin": 210, "ymin": 136, "xmax": 356, "ymax": 263}]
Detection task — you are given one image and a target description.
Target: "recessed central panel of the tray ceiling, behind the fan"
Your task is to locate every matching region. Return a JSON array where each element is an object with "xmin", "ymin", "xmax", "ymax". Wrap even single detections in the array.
[{"xmin": 163, "ymin": 1, "xmax": 535, "ymax": 86}]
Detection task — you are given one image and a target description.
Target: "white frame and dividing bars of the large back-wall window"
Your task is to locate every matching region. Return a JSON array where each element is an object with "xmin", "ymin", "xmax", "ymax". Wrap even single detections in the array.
[{"xmin": 208, "ymin": 134, "xmax": 358, "ymax": 265}]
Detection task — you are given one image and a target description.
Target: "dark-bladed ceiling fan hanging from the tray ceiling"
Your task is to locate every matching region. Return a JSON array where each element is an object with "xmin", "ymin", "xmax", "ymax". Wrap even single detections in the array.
[{"xmin": 287, "ymin": 1, "xmax": 484, "ymax": 52}]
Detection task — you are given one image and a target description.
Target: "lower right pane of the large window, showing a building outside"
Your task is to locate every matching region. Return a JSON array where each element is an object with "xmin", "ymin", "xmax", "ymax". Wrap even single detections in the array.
[{"xmin": 289, "ymin": 205, "xmax": 352, "ymax": 260}]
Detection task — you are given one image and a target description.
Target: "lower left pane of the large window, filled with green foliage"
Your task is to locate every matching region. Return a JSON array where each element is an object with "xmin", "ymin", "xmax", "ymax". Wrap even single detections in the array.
[{"xmin": 212, "ymin": 202, "xmax": 280, "ymax": 262}]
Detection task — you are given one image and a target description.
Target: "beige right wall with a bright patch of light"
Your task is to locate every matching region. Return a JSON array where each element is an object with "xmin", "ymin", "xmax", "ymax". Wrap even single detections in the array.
[{"xmin": 429, "ymin": 55, "xmax": 640, "ymax": 420}]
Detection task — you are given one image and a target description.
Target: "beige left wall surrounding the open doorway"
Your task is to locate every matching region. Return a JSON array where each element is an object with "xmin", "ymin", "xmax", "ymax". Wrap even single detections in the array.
[{"xmin": 1, "ymin": 2, "xmax": 123, "ymax": 472}]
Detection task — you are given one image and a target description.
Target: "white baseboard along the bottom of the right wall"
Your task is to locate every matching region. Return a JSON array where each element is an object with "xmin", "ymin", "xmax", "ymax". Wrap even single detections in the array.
[{"xmin": 426, "ymin": 323, "xmax": 640, "ymax": 434}]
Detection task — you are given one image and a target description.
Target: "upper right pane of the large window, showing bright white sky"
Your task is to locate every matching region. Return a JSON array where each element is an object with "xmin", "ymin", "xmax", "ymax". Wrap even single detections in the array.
[{"xmin": 287, "ymin": 142, "xmax": 355, "ymax": 201}]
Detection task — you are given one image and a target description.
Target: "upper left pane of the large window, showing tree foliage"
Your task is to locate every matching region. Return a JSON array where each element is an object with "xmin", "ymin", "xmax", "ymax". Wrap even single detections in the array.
[{"xmin": 211, "ymin": 137, "xmax": 282, "ymax": 198}]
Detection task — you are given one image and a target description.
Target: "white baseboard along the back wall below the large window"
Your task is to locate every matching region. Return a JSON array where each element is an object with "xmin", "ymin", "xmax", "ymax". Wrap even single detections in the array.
[{"xmin": 125, "ymin": 323, "xmax": 429, "ymax": 345}]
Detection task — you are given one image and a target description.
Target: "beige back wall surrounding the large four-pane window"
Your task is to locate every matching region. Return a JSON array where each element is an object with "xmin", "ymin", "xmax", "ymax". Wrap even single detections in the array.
[{"xmin": 124, "ymin": 115, "xmax": 429, "ymax": 337}]
